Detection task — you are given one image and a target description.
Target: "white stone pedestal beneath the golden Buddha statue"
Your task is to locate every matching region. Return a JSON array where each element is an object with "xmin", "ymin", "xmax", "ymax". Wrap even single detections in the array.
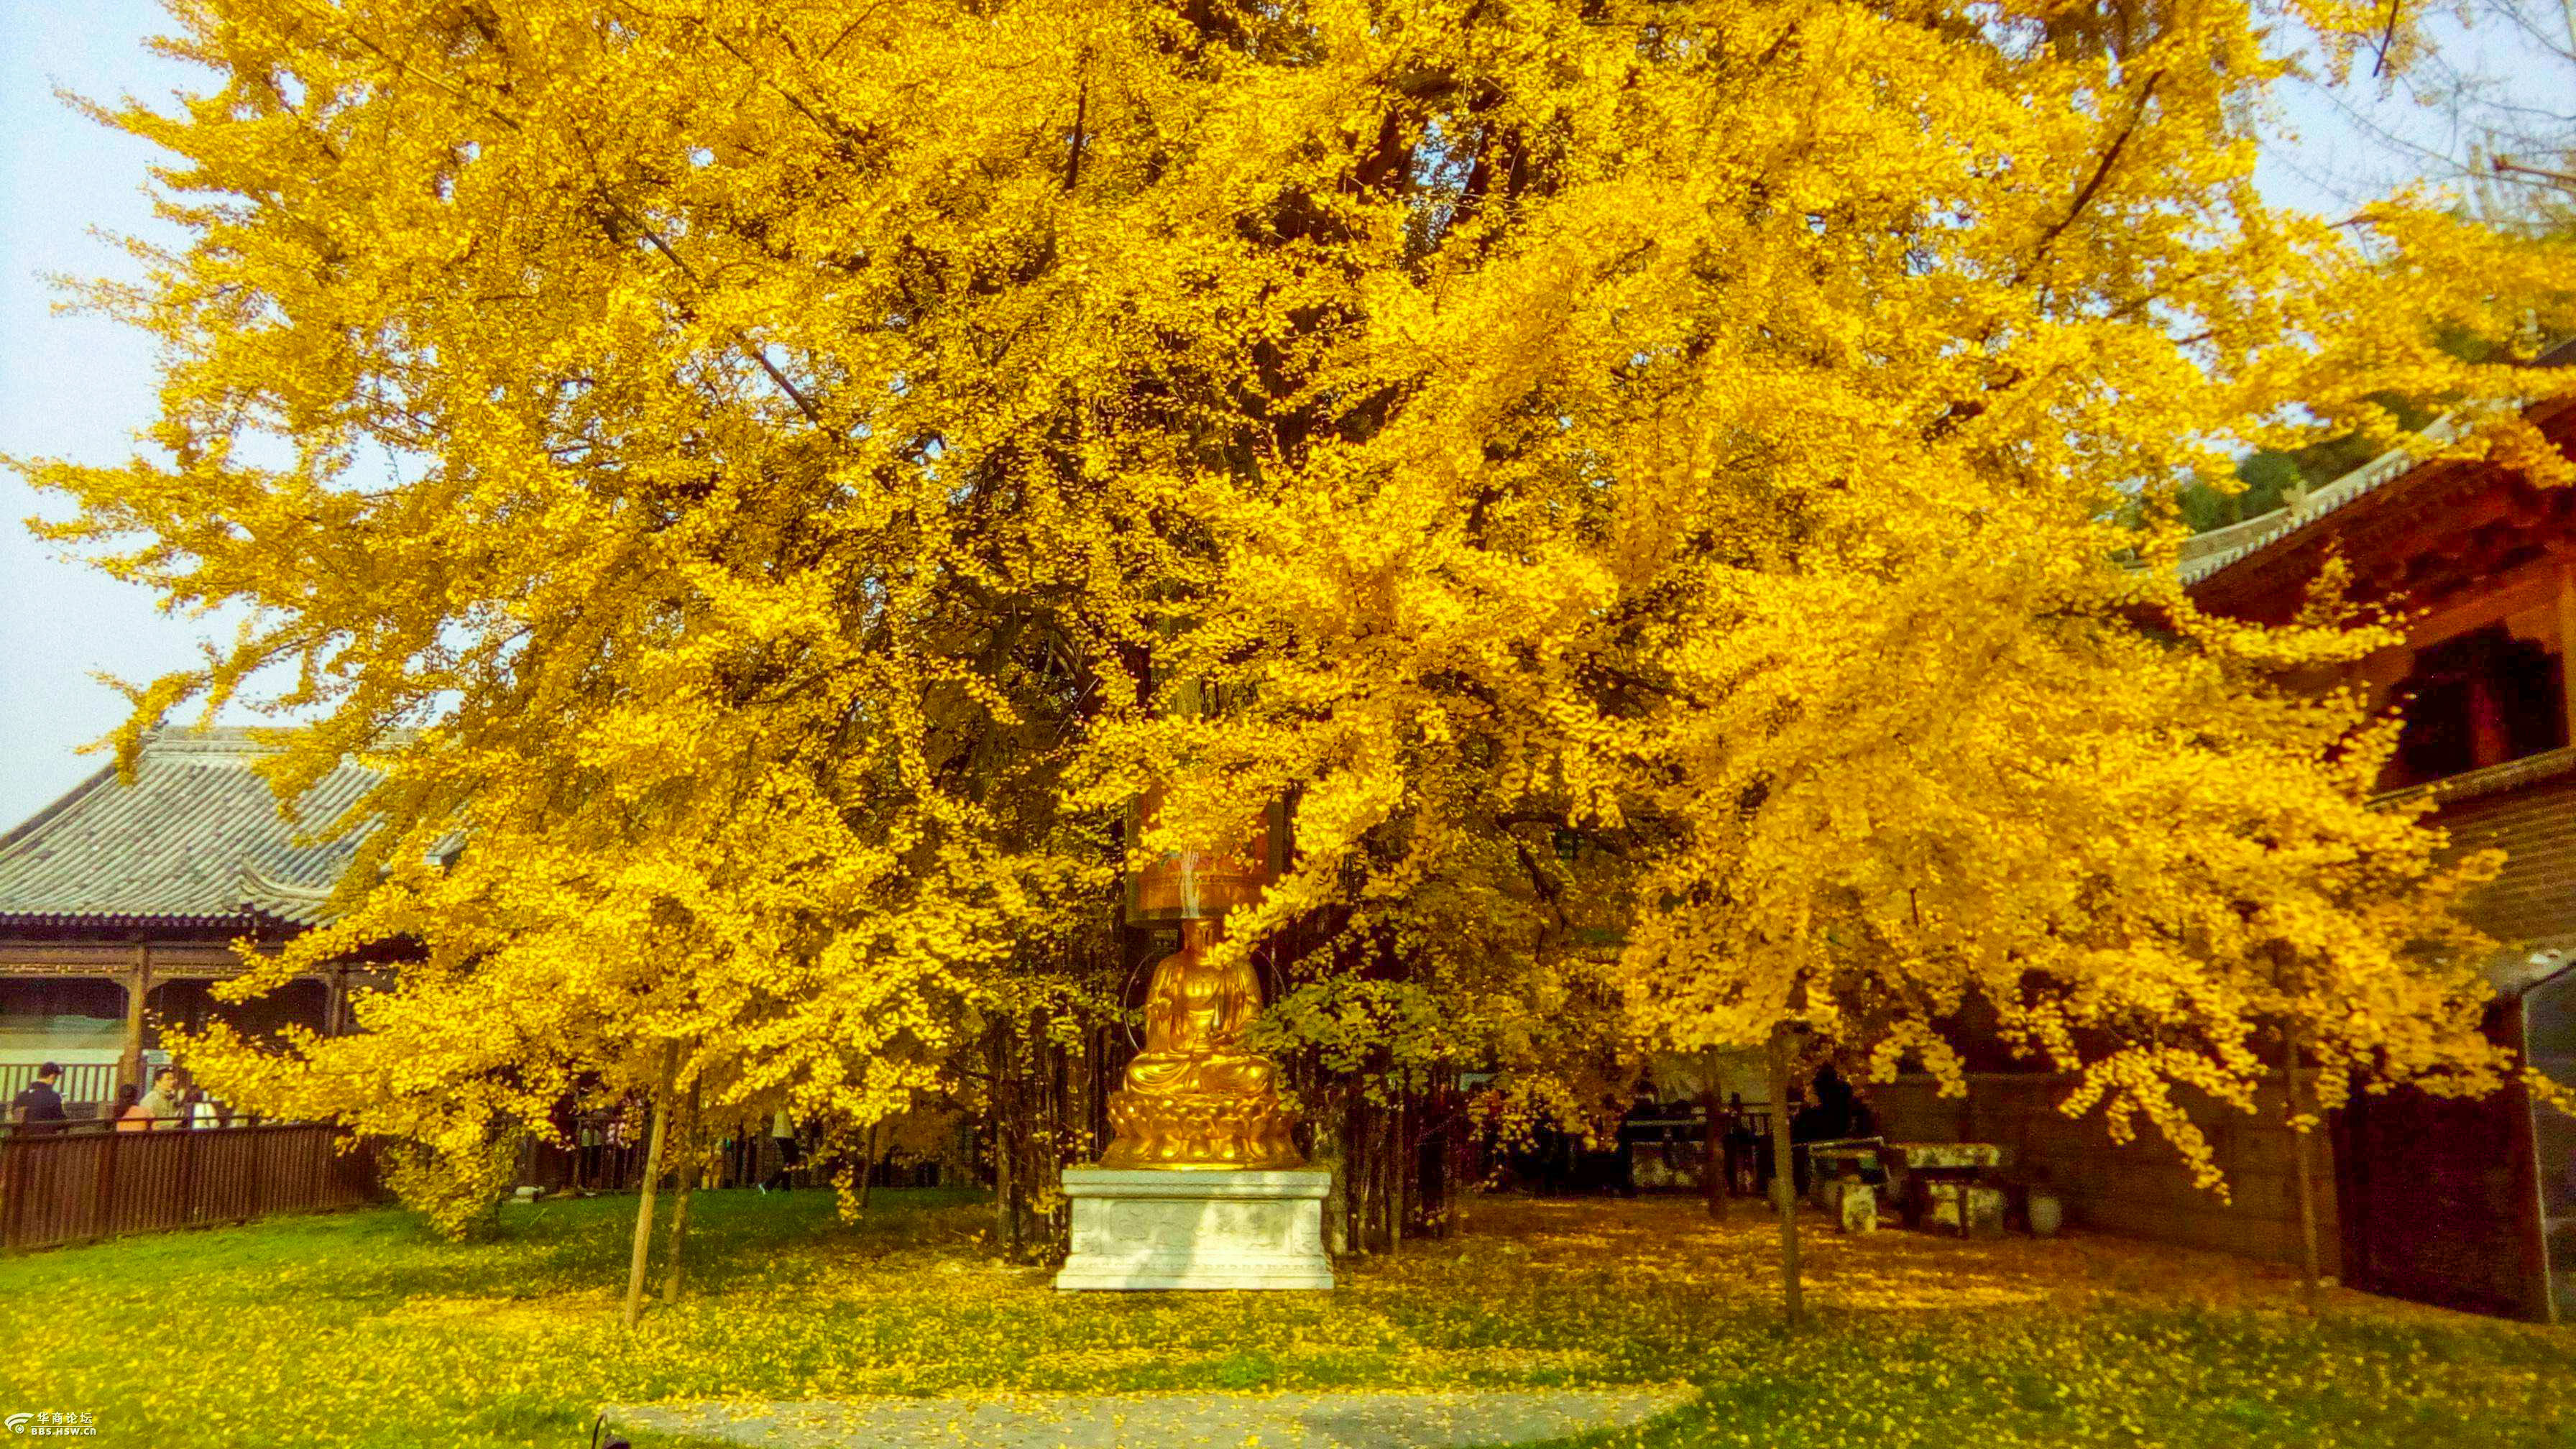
[{"xmin": 1056, "ymin": 1168, "xmax": 1332, "ymax": 1292}]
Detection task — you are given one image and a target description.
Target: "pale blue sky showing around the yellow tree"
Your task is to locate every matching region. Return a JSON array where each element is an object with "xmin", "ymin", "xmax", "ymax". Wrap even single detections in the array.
[{"xmin": 0, "ymin": 0, "xmax": 2566, "ymax": 830}]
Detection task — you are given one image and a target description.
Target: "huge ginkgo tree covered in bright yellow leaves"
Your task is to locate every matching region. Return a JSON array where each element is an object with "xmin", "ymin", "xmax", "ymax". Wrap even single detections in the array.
[{"xmin": 23, "ymin": 0, "xmax": 2571, "ymax": 1310}]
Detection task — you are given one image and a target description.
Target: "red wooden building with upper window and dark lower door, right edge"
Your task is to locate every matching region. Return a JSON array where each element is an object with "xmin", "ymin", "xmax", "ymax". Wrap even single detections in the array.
[{"xmin": 2182, "ymin": 356, "xmax": 2576, "ymax": 1320}]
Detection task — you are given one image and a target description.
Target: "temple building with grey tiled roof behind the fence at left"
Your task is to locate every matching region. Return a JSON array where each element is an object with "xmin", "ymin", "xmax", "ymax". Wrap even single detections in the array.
[{"xmin": 0, "ymin": 730, "xmax": 374, "ymax": 1114}]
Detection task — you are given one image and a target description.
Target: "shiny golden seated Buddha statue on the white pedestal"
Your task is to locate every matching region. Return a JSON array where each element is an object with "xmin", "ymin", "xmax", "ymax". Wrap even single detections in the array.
[{"xmin": 1100, "ymin": 918, "xmax": 1304, "ymax": 1168}]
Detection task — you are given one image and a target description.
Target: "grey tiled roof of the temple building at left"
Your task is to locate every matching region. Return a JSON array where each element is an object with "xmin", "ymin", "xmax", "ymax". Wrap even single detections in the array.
[{"xmin": 0, "ymin": 730, "xmax": 376, "ymax": 928}]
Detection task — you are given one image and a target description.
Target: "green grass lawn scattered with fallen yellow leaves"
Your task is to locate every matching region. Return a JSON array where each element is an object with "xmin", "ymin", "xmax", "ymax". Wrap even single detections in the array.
[{"xmin": 0, "ymin": 1191, "xmax": 2576, "ymax": 1449}]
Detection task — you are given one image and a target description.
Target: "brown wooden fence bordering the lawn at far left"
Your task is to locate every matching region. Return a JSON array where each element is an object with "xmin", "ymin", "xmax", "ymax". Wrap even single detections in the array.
[{"xmin": 0, "ymin": 1121, "xmax": 384, "ymax": 1251}]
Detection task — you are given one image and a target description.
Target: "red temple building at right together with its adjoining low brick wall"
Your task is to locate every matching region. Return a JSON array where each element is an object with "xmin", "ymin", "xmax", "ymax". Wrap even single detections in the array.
[{"xmin": 1870, "ymin": 348, "xmax": 2576, "ymax": 1322}]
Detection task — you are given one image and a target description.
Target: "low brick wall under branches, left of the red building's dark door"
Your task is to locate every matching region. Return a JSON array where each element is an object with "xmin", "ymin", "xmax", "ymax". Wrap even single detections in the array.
[{"xmin": 1862, "ymin": 1072, "xmax": 2342, "ymax": 1274}]
